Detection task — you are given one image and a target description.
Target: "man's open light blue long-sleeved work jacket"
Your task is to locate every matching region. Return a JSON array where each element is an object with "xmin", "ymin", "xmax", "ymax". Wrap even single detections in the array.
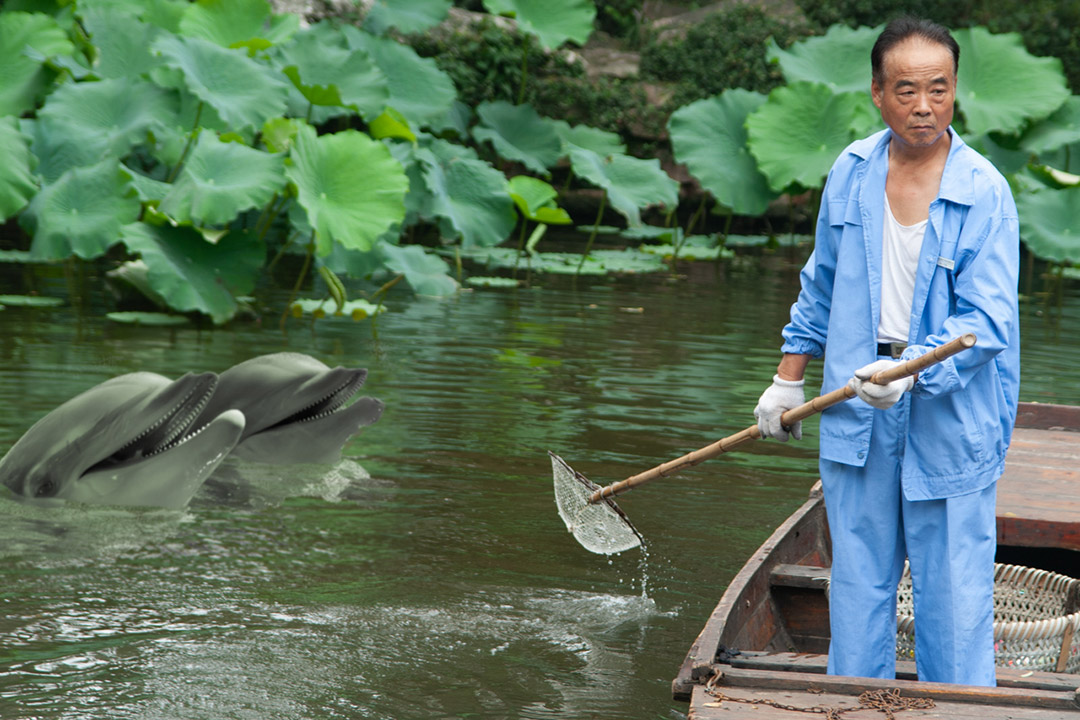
[{"xmin": 782, "ymin": 128, "xmax": 1020, "ymax": 500}]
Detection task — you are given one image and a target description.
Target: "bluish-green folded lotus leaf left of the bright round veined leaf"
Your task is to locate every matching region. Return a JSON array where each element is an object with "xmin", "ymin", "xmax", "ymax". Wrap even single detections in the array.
[{"xmin": 667, "ymin": 89, "xmax": 777, "ymax": 215}]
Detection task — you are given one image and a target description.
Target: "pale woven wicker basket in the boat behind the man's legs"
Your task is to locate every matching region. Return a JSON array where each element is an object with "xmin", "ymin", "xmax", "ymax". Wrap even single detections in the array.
[{"xmin": 896, "ymin": 563, "xmax": 1080, "ymax": 673}]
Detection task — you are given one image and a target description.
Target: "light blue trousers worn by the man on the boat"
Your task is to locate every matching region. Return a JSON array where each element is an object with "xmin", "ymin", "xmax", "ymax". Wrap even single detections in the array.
[{"xmin": 821, "ymin": 395, "xmax": 997, "ymax": 685}]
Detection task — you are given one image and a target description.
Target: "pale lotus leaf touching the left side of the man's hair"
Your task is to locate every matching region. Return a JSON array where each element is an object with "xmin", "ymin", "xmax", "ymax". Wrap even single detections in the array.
[{"xmin": 767, "ymin": 25, "xmax": 881, "ymax": 94}]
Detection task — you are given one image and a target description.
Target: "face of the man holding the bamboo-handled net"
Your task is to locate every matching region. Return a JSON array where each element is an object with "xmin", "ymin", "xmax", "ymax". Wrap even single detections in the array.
[{"xmin": 870, "ymin": 37, "xmax": 956, "ymax": 148}]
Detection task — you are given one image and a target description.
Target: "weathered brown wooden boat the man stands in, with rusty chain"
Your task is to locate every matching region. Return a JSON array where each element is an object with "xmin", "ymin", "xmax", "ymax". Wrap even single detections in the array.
[{"xmin": 672, "ymin": 403, "xmax": 1080, "ymax": 720}]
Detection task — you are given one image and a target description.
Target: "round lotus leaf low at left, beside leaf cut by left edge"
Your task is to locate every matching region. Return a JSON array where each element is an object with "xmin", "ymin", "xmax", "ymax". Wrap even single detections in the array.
[{"xmin": 19, "ymin": 158, "xmax": 140, "ymax": 260}]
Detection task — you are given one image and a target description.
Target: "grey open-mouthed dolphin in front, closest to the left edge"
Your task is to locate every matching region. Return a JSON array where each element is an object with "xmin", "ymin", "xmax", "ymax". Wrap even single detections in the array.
[{"xmin": 0, "ymin": 372, "xmax": 245, "ymax": 510}]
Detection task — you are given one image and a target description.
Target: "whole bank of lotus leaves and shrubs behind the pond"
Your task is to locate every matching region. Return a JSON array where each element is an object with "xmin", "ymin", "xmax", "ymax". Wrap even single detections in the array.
[{"xmin": 0, "ymin": 0, "xmax": 1080, "ymax": 326}]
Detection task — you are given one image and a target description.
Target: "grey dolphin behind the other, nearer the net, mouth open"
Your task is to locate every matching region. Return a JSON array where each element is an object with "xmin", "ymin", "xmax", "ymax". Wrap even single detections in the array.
[{"xmin": 200, "ymin": 352, "xmax": 383, "ymax": 464}]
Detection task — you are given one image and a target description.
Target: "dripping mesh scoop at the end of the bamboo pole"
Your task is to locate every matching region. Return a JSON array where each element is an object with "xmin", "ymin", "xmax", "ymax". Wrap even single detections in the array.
[{"xmin": 548, "ymin": 452, "xmax": 644, "ymax": 555}]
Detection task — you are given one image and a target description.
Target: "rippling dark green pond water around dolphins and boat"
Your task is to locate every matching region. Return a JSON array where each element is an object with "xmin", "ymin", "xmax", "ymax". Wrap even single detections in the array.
[{"xmin": 0, "ymin": 258, "xmax": 1080, "ymax": 720}]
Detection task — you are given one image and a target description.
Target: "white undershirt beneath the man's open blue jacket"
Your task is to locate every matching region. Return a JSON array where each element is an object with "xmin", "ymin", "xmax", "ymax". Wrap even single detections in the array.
[{"xmin": 878, "ymin": 193, "xmax": 927, "ymax": 342}]
